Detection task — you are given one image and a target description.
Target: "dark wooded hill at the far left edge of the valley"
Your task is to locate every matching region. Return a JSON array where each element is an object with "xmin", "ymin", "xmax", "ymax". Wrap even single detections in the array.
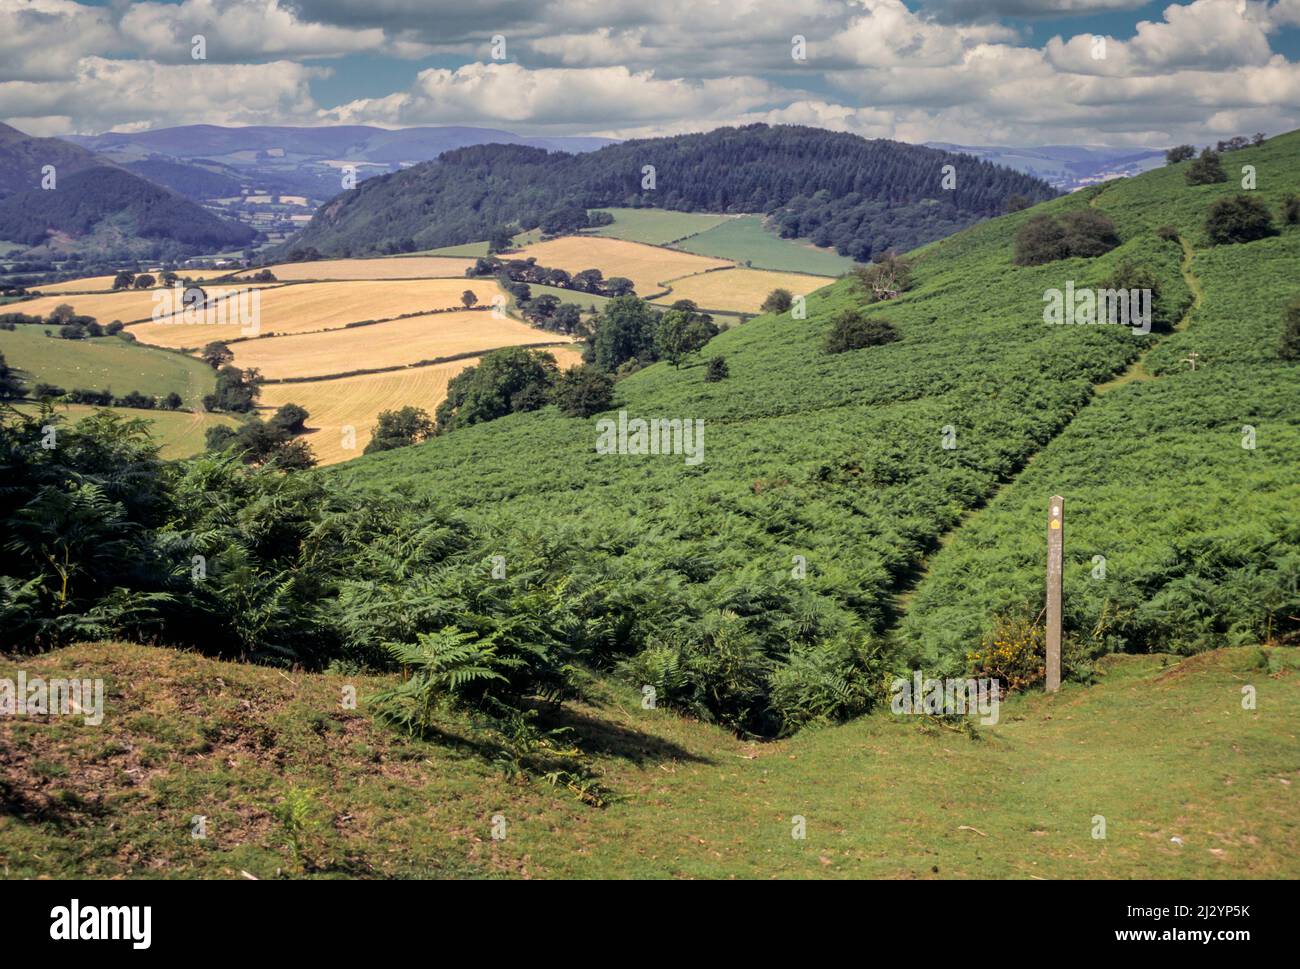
[{"xmin": 0, "ymin": 124, "xmax": 256, "ymax": 258}]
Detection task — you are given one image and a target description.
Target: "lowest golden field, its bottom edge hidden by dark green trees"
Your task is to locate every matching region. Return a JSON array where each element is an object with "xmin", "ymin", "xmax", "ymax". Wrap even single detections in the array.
[{"xmin": 261, "ymin": 346, "xmax": 582, "ymax": 464}]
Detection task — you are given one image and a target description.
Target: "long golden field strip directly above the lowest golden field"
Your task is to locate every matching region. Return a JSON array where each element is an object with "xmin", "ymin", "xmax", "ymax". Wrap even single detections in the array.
[{"xmin": 230, "ymin": 310, "xmax": 568, "ymax": 380}]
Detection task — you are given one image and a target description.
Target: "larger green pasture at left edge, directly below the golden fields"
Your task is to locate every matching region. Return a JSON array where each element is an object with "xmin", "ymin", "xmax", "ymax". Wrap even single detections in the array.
[{"xmin": 0, "ymin": 324, "xmax": 216, "ymax": 408}]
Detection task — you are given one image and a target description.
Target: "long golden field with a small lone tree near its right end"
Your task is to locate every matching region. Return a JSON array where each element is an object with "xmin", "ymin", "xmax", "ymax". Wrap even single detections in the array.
[{"xmin": 131, "ymin": 280, "xmax": 502, "ymax": 348}]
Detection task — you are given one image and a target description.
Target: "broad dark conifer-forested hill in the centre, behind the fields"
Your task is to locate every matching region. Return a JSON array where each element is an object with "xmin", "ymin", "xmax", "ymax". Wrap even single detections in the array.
[{"xmin": 286, "ymin": 125, "xmax": 1054, "ymax": 260}]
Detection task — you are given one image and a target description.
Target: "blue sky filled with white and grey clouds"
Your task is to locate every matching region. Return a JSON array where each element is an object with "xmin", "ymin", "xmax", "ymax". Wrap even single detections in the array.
[{"xmin": 0, "ymin": 0, "xmax": 1300, "ymax": 147}]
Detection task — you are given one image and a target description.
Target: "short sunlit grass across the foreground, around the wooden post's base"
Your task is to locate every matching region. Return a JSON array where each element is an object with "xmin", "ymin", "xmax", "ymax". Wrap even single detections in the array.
[{"xmin": 0, "ymin": 644, "xmax": 1300, "ymax": 878}]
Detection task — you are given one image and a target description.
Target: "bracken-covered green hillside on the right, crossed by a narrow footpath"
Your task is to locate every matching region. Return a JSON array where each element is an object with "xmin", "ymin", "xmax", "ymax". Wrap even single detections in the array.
[{"xmin": 333, "ymin": 134, "xmax": 1300, "ymax": 732}]
